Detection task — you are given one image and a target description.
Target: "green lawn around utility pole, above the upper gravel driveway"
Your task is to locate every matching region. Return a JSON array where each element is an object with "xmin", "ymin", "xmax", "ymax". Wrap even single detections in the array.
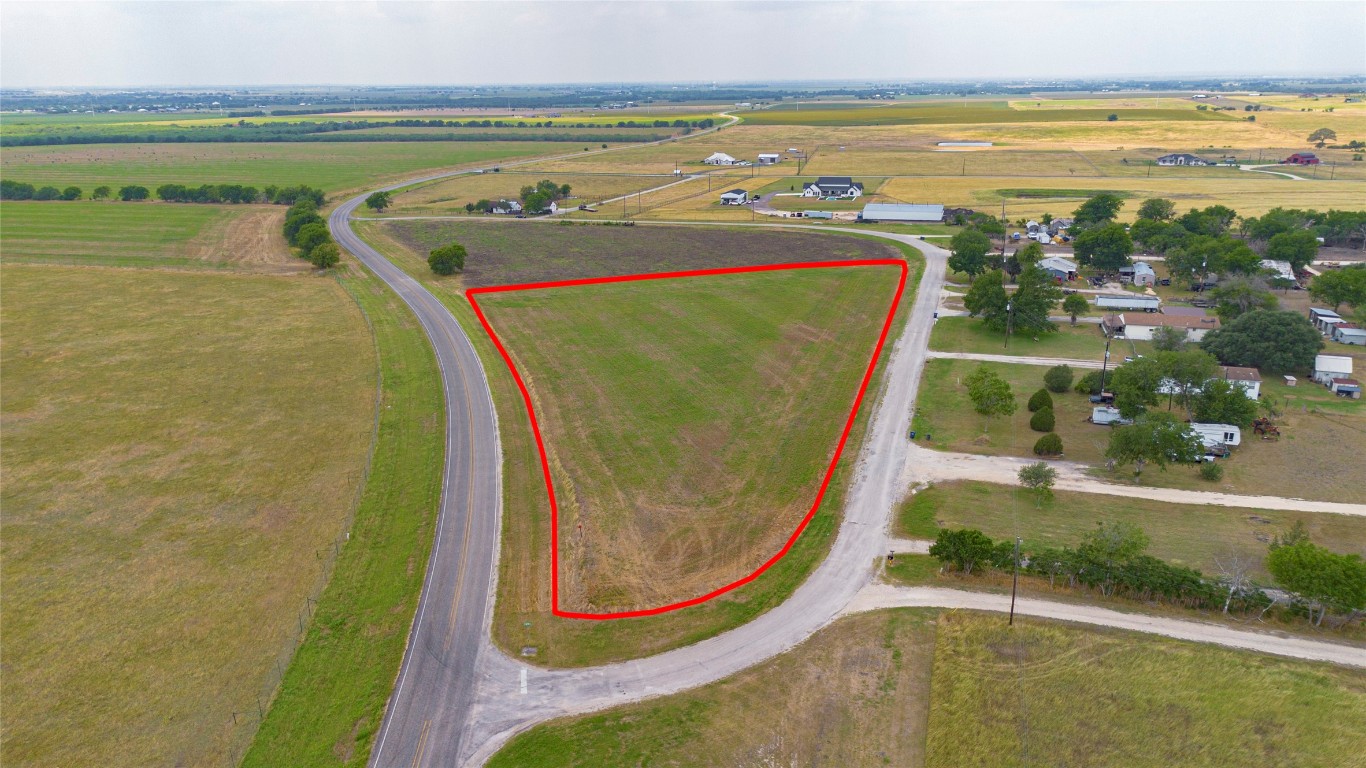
[{"xmin": 930, "ymin": 317, "xmax": 1109, "ymax": 360}]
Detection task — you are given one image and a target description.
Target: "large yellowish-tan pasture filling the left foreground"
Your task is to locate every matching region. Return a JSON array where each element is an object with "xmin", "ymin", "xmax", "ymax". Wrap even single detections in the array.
[{"xmin": 0, "ymin": 265, "xmax": 376, "ymax": 767}]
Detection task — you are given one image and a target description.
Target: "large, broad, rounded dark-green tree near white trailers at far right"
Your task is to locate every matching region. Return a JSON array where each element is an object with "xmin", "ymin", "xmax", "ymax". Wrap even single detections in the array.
[{"xmin": 1199, "ymin": 310, "xmax": 1324, "ymax": 373}]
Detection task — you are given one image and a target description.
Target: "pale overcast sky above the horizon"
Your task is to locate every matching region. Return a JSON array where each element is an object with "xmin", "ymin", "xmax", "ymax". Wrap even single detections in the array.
[{"xmin": 0, "ymin": 0, "xmax": 1366, "ymax": 87}]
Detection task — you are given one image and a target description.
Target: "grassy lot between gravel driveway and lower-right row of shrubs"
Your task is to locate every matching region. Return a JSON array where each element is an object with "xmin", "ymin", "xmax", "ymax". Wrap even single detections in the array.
[{"xmin": 897, "ymin": 482, "xmax": 1366, "ymax": 579}]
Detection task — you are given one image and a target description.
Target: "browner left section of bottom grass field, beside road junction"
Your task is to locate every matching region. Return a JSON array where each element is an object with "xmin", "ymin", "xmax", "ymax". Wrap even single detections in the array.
[{"xmin": 489, "ymin": 611, "xmax": 936, "ymax": 768}]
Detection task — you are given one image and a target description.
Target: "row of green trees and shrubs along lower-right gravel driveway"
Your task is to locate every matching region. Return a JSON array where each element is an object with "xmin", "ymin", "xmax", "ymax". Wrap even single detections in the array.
[{"xmin": 930, "ymin": 522, "xmax": 1366, "ymax": 626}]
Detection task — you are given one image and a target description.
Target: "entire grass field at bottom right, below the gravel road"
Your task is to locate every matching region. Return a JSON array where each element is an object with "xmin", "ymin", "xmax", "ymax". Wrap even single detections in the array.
[{"xmin": 489, "ymin": 609, "xmax": 1366, "ymax": 768}]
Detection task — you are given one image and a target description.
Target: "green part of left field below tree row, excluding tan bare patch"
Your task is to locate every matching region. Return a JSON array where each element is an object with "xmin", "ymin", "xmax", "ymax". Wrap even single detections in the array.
[{"xmin": 0, "ymin": 201, "xmax": 243, "ymax": 266}]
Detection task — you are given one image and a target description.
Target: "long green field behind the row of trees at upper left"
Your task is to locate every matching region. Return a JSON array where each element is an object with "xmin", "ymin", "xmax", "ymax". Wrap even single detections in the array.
[{"xmin": 4, "ymin": 141, "xmax": 566, "ymax": 194}]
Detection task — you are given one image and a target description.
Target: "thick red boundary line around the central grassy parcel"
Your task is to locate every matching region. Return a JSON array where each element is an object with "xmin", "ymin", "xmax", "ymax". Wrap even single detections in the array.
[{"xmin": 464, "ymin": 258, "xmax": 908, "ymax": 620}]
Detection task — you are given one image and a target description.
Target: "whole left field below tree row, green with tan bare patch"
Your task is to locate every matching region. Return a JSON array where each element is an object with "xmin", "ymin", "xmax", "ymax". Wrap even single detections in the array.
[{"xmin": 0, "ymin": 201, "xmax": 293, "ymax": 272}]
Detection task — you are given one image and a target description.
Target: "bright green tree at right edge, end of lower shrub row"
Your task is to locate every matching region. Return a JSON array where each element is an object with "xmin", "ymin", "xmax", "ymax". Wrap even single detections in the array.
[{"xmin": 1266, "ymin": 541, "xmax": 1366, "ymax": 626}]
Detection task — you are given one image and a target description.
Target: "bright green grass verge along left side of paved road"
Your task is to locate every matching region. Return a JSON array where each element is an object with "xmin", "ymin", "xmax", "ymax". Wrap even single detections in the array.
[{"xmin": 242, "ymin": 265, "xmax": 444, "ymax": 767}]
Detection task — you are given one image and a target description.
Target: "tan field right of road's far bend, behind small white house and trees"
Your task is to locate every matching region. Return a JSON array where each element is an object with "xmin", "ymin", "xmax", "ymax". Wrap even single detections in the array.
[{"xmin": 385, "ymin": 171, "xmax": 676, "ymax": 216}]
